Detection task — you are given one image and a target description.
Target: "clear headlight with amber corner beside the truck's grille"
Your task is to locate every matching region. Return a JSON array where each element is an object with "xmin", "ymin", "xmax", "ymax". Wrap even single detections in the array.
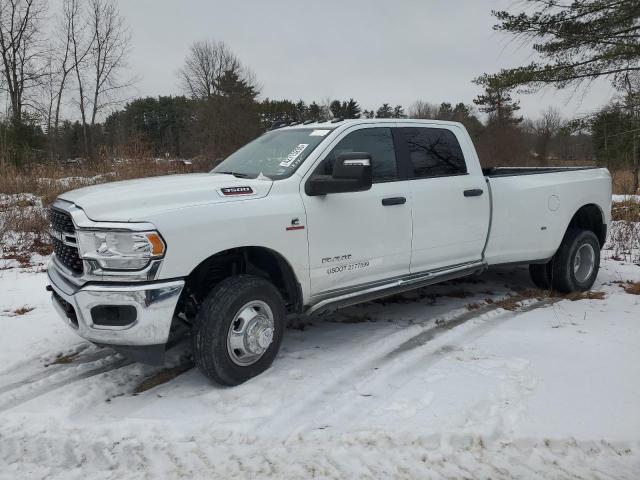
[{"xmin": 76, "ymin": 230, "xmax": 165, "ymax": 270}]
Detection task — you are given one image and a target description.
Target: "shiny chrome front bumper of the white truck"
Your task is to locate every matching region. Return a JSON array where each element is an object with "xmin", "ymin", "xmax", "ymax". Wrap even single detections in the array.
[{"xmin": 47, "ymin": 260, "xmax": 184, "ymax": 347}]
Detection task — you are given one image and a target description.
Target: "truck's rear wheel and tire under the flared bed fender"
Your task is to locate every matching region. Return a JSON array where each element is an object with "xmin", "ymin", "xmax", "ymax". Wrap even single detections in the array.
[{"xmin": 551, "ymin": 229, "xmax": 600, "ymax": 293}]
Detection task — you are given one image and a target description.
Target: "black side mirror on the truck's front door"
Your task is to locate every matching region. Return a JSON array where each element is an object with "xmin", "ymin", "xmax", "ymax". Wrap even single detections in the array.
[{"xmin": 305, "ymin": 152, "xmax": 373, "ymax": 196}]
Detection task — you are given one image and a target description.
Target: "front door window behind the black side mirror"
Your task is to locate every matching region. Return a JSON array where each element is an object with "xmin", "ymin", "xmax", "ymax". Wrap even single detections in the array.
[{"xmin": 316, "ymin": 128, "xmax": 398, "ymax": 183}]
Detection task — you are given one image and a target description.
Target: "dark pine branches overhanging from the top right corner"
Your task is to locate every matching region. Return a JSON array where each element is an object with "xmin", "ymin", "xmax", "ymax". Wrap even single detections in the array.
[{"xmin": 480, "ymin": 0, "xmax": 640, "ymax": 91}]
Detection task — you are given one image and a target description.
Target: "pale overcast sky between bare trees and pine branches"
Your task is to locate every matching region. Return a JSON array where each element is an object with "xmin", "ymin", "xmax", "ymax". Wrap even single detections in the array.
[{"xmin": 119, "ymin": 0, "xmax": 614, "ymax": 117}]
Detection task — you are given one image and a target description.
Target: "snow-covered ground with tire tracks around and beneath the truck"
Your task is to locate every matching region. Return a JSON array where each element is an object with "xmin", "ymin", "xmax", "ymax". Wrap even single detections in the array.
[{"xmin": 0, "ymin": 255, "xmax": 640, "ymax": 479}]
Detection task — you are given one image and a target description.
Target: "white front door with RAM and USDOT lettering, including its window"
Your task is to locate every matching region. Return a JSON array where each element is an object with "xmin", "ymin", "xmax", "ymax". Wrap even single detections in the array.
[{"xmin": 302, "ymin": 125, "xmax": 412, "ymax": 297}]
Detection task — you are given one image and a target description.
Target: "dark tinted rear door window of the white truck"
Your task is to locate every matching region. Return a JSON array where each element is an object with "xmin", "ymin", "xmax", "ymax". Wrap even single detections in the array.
[{"xmin": 402, "ymin": 128, "xmax": 467, "ymax": 178}]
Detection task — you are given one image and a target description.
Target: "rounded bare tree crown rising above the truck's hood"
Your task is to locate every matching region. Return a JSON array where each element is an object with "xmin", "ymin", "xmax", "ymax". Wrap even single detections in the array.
[{"xmin": 178, "ymin": 40, "xmax": 254, "ymax": 99}]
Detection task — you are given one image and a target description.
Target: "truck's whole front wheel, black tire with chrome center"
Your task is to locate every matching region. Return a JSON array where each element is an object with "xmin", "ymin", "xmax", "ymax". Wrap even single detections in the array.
[{"xmin": 192, "ymin": 275, "xmax": 286, "ymax": 386}]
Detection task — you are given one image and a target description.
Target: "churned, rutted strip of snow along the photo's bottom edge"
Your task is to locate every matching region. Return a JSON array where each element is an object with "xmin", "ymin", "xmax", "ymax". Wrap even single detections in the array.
[{"xmin": 0, "ymin": 428, "xmax": 640, "ymax": 480}]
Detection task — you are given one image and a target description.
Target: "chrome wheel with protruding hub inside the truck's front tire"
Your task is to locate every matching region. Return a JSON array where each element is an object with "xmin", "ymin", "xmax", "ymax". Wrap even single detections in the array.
[{"xmin": 227, "ymin": 300, "xmax": 275, "ymax": 367}]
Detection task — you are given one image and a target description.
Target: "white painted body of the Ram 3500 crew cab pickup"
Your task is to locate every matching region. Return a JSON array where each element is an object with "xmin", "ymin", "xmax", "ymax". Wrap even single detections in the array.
[{"xmin": 50, "ymin": 119, "xmax": 611, "ymax": 374}]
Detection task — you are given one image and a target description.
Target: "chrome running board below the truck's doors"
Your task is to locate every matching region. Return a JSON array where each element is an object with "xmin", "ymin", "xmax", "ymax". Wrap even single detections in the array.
[{"xmin": 304, "ymin": 262, "xmax": 487, "ymax": 316}]
